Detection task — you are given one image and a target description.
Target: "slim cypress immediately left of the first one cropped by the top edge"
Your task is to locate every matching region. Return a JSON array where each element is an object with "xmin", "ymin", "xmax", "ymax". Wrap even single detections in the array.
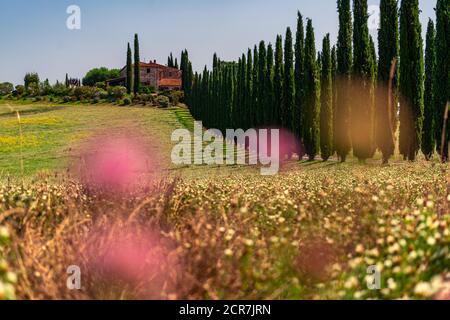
[{"xmin": 320, "ymin": 34, "xmax": 333, "ymax": 161}]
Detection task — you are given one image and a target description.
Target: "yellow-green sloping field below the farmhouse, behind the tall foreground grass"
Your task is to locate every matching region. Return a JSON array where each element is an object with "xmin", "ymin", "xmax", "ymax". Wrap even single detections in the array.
[{"xmin": 0, "ymin": 103, "xmax": 191, "ymax": 176}]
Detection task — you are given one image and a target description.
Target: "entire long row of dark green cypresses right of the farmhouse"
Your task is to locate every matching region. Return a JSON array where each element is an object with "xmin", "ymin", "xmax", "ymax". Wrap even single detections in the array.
[{"xmin": 180, "ymin": 0, "xmax": 450, "ymax": 162}]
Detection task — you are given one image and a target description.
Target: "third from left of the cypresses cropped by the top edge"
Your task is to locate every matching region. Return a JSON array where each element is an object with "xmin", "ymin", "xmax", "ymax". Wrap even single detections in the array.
[{"xmin": 375, "ymin": 0, "xmax": 399, "ymax": 163}]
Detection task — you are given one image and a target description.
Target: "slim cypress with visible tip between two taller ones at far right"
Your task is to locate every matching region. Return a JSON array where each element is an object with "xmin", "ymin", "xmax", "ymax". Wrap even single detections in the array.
[{"xmin": 422, "ymin": 19, "xmax": 436, "ymax": 160}]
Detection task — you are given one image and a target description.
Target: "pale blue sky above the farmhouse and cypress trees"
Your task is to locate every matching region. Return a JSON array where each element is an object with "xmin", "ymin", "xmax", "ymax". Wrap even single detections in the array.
[{"xmin": 0, "ymin": 0, "xmax": 436, "ymax": 84}]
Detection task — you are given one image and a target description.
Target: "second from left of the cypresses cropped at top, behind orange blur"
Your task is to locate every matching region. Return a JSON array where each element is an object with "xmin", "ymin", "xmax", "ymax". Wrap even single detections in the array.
[{"xmin": 350, "ymin": 0, "xmax": 373, "ymax": 161}]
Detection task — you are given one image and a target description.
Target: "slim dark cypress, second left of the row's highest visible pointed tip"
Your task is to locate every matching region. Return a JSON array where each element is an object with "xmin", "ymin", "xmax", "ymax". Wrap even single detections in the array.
[{"xmin": 273, "ymin": 35, "xmax": 284, "ymax": 126}]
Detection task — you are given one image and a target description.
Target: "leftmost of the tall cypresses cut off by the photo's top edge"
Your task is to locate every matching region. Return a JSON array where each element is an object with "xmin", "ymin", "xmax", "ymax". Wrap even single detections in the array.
[{"xmin": 334, "ymin": 0, "xmax": 352, "ymax": 162}]
